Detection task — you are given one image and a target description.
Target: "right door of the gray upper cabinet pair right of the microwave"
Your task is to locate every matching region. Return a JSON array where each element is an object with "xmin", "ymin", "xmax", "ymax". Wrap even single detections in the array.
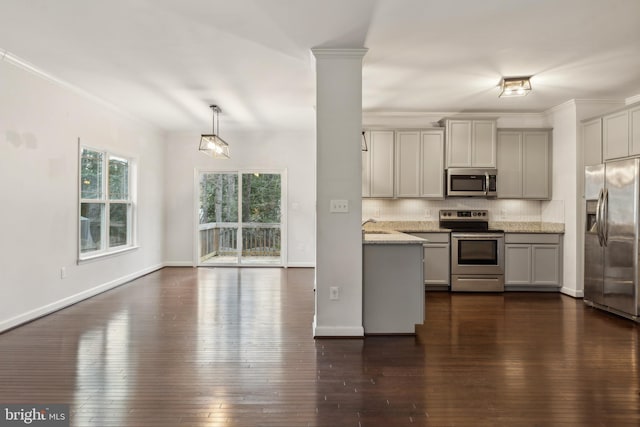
[{"xmin": 522, "ymin": 131, "xmax": 551, "ymax": 200}]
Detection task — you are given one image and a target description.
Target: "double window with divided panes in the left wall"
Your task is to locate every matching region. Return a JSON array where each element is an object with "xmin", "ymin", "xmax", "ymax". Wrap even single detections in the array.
[{"xmin": 79, "ymin": 147, "xmax": 134, "ymax": 259}]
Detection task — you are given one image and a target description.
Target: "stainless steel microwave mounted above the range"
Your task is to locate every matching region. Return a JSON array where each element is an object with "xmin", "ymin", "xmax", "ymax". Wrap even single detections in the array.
[{"xmin": 447, "ymin": 168, "xmax": 498, "ymax": 197}]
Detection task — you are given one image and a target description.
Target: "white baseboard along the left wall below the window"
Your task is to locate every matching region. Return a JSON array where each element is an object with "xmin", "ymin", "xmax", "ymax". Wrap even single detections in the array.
[{"xmin": 0, "ymin": 264, "xmax": 164, "ymax": 333}]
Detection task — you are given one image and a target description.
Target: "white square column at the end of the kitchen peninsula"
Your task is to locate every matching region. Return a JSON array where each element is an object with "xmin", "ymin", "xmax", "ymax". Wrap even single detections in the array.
[{"xmin": 312, "ymin": 48, "xmax": 367, "ymax": 337}]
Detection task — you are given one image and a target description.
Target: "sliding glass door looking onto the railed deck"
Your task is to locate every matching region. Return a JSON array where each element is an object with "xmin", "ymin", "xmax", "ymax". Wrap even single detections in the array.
[{"xmin": 198, "ymin": 172, "xmax": 283, "ymax": 265}]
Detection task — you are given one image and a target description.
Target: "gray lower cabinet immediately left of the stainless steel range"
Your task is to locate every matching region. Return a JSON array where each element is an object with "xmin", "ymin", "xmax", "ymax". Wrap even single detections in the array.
[{"xmin": 411, "ymin": 233, "xmax": 451, "ymax": 291}]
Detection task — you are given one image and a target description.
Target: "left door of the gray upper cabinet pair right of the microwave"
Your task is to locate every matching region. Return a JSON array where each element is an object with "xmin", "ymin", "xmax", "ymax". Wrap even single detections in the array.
[{"xmin": 497, "ymin": 131, "xmax": 522, "ymax": 199}]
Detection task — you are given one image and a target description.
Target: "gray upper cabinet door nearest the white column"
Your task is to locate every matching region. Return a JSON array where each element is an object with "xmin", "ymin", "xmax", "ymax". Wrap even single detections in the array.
[{"xmin": 369, "ymin": 130, "xmax": 394, "ymax": 197}]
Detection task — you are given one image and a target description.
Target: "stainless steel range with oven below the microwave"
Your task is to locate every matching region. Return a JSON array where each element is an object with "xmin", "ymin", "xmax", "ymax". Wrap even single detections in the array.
[{"xmin": 440, "ymin": 210, "xmax": 504, "ymax": 292}]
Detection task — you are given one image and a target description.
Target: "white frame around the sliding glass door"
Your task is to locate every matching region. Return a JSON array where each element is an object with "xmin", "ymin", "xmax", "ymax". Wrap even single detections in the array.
[{"xmin": 192, "ymin": 168, "xmax": 289, "ymax": 268}]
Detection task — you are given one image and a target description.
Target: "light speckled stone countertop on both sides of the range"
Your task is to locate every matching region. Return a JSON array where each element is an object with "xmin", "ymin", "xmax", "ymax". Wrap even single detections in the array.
[{"xmin": 364, "ymin": 221, "xmax": 564, "ymax": 237}]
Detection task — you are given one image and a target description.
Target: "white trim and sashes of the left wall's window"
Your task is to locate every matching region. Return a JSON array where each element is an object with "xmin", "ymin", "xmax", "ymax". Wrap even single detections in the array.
[{"xmin": 76, "ymin": 142, "xmax": 140, "ymax": 264}]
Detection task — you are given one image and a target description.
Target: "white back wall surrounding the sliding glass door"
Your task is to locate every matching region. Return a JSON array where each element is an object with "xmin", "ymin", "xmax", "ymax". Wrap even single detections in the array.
[{"xmin": 164, "ymin": 126, "xmax": 315, "ymax": 267}]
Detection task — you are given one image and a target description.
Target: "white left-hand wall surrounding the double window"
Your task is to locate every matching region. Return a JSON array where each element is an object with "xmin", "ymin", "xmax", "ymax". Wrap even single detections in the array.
[{"xmin": 0, "ymin": 60, "xmax": 163, "ymax": 331}]
